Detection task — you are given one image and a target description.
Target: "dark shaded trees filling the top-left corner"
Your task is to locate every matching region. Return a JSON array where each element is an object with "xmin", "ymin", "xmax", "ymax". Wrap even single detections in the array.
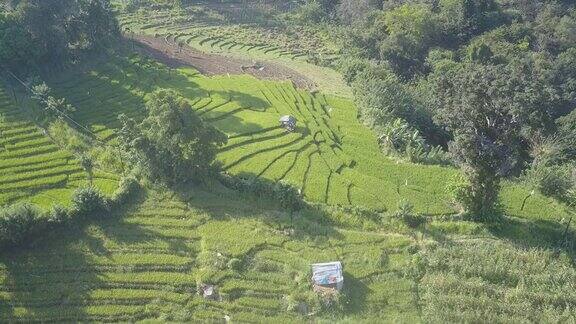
[{"xmin": 0, "ymin": 0, "xmax": 119, "ymax": 70}]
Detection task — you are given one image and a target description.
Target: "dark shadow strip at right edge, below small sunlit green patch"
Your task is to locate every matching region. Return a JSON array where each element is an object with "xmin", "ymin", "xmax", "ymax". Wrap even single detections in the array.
[{"xmin": 490, "ymin": 217, "xmax": 576, "ymax": 265}]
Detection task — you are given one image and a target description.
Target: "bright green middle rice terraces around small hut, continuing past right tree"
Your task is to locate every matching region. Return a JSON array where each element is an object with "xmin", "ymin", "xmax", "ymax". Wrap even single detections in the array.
[{"xmin": 51, "ymin": 55, "xmax": 564, "ymax": 218}]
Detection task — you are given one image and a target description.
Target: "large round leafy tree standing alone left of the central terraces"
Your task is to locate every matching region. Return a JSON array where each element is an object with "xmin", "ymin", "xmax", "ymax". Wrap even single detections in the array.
[{"xmin": 120, "ymin": 90, "xmax": 226, "ymax": 184}]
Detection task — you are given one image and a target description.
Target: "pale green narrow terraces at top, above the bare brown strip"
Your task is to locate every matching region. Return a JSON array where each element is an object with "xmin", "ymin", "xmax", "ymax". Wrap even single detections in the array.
[{"xmin": 118, "ymin": 7, "xmax": 352, "ymax": 97}]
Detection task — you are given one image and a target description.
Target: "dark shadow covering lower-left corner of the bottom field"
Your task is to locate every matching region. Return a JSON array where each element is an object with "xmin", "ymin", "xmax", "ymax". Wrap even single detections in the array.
[{"xmin": 0, "ymin": 221, "xmax": 103, "ymax": 322}]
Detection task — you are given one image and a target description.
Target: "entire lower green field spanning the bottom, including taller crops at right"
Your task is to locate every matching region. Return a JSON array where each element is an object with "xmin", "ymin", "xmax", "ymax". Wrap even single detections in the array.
[{"xmin": 0, "ymin": 188, "xmax": 576, "ymax": 323}]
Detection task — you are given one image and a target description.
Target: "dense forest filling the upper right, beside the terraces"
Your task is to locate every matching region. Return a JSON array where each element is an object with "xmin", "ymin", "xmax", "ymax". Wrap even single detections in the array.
[{"xmin": 296, "ymin": 0, "xmax": 576, "ymax": 219}]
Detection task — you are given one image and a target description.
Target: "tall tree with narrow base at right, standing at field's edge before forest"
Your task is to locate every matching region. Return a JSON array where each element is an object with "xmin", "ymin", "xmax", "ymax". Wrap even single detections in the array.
[{"xmin": 435, "ymin": 64, "xmax": 546, "ymax": 217}]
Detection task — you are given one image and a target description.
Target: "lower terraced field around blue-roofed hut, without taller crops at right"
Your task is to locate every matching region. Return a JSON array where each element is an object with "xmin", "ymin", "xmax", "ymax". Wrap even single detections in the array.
[{"xmin": 0, "ymin": 191, "xmax": 418, "ymax": 322}]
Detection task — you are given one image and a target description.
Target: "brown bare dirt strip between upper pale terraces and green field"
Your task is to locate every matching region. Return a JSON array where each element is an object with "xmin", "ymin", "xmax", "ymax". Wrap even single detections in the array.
[{"xmin": 134, "ymin": 35, "xmax": 316, "ymax": 90}]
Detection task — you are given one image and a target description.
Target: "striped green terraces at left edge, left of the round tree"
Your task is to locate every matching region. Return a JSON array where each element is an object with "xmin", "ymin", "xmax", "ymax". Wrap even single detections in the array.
[{"xmin": 0, "ymin": 89, "xmax": 118, "ymax": 207}]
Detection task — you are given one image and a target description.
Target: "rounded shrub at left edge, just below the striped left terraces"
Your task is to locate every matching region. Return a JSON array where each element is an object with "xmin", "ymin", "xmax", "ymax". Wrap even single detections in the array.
[{"xmin": 0, "ymin": 204, "xmax": 45, "ymax": 248}]
